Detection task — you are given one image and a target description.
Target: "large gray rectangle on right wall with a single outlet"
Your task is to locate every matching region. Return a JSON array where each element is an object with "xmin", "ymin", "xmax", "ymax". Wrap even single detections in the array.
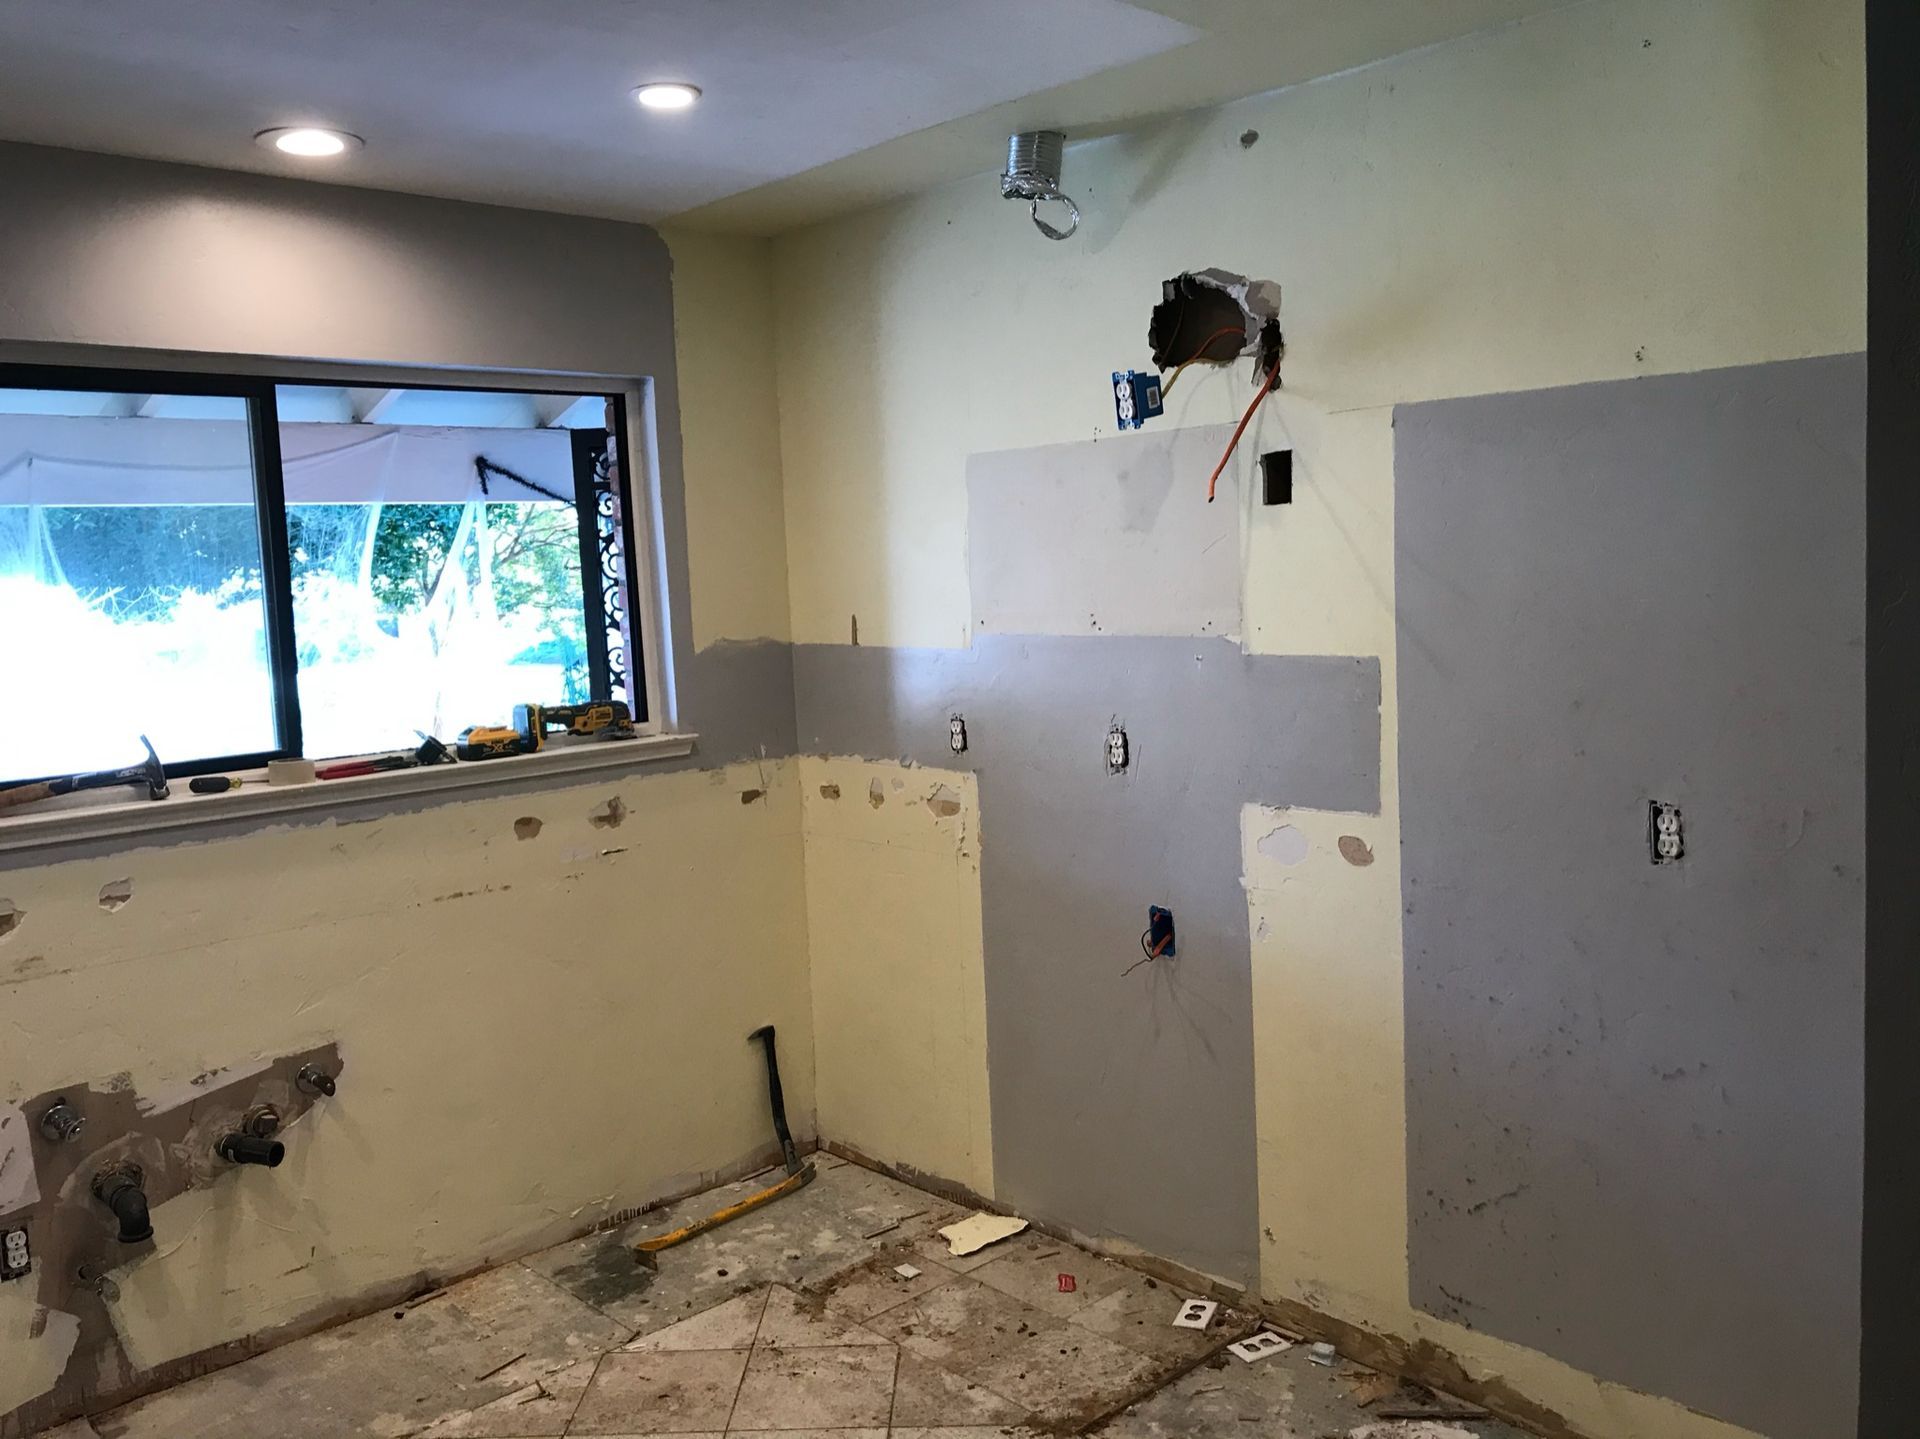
[{"xmin": 1394, "ymin": 357, "xmax": 1866, "ymax": 1439}]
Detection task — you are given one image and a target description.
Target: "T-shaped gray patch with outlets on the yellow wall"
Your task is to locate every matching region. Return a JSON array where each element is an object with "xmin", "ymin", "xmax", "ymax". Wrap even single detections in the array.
[{"xmin": 795, "ymin": 636, "xmax": 1380, "ymax": 1281}]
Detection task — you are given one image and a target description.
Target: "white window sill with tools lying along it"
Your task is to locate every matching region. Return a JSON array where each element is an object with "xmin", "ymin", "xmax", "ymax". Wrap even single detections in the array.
[{"xmin": 0, "ymin": 734, "xmax": 699, "ymax": 853}]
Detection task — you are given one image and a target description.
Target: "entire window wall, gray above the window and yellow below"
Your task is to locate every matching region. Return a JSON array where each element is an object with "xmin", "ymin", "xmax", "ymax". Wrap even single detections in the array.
[{"xmin": 0, "ymin": 146, "xmax": 812, "ymax": 1433}]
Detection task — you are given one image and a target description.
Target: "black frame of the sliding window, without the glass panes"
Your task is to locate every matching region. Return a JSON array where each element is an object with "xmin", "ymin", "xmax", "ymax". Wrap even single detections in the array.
[{"xmin": 0, "ymin": 361, "xmax": 649, "ymax": 784}]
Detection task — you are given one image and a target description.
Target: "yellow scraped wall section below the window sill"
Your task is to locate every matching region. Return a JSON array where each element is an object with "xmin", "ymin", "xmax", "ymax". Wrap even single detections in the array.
[{"xmin": 0, "ymin": 761, "xmax": 812, "ymax": 1412}]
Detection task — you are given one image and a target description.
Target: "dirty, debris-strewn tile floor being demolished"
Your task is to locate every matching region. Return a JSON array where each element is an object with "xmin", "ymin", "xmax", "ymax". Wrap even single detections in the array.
[{"xmin": 58, "ymin": 1155, "xmax": 1519, "ymax": 1439}]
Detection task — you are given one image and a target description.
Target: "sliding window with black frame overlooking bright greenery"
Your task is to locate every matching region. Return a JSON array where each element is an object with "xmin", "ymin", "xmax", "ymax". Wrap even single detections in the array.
[{"xmin": 0, "ymin": 367, "xmax": 645, "ymax": 782}]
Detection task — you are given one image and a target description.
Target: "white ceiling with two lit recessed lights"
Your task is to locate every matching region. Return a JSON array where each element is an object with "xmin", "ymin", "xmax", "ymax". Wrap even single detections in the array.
[{"xmin": 0, "ymin": 0, "xmax": 1569, "ymax": 232}]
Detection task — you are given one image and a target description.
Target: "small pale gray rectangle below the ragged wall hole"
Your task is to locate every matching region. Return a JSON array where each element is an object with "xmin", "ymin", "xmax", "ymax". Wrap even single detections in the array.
[{"xmin": 968, "ymin": 425, "xmax": 1240, "ymax": 636}]
